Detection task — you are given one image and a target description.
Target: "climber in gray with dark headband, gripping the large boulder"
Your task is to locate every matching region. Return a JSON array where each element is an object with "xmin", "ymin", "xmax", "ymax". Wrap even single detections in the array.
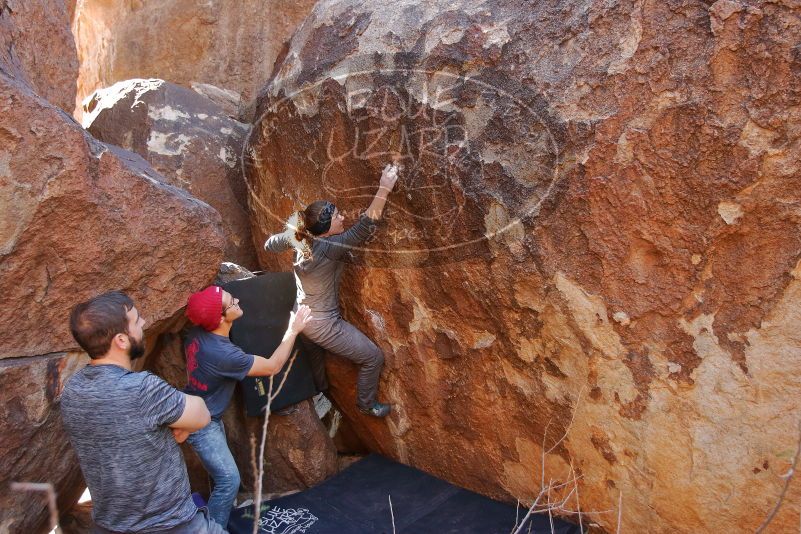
[{"xmin": 264, "ymin": 165, "xmax": 398, "ymax": 417}]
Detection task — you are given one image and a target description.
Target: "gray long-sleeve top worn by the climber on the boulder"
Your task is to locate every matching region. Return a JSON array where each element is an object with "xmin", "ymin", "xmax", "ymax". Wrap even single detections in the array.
[{"xmin": 264, "ymin": 215, "xmax": 376, "ymax": 318}]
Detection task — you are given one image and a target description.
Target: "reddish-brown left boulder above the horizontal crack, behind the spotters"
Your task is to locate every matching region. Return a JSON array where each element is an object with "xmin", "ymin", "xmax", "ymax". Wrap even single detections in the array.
[{"xmin": 0, "ymin": 78, "xmax": 222, "ymax": 358}]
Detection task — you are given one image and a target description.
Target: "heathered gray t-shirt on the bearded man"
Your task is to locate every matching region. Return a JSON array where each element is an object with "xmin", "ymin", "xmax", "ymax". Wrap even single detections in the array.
[{"xmin": 61, "ymin": 365, "xmax": 197, "ymax": 532}]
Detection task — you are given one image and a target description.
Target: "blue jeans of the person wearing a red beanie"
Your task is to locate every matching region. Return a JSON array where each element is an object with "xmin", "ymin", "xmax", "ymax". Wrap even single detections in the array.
[{"xmin": 187, "ymin": 419, "xmax": 239, "ymax": 528}]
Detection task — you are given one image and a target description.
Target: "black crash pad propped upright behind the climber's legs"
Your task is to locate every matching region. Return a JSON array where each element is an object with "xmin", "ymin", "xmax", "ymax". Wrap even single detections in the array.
[{"xmin": 223, "ymin": 273, "xmax": 317, "ymax": 416}]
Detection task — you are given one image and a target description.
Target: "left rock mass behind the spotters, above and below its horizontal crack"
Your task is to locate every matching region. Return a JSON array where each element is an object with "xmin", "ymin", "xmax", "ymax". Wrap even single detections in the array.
[{"xmin": 0, "ymin": 69, "xmax": 223, "ymax": 533}]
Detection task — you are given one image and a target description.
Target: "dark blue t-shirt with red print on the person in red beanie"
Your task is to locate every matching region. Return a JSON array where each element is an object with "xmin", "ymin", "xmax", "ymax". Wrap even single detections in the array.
[{"xmin": 184, "ymin": 327, "xmax": 253, "ymax": 419}]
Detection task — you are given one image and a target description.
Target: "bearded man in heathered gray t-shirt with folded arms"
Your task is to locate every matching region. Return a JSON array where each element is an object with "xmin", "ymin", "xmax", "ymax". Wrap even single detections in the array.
[{"xmin": 61, "ymin": 292, "xmax": 224, "ymax": 534}]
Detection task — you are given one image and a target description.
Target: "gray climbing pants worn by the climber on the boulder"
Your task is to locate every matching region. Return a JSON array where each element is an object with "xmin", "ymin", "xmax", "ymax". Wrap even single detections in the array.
[{"xmin": 302, "ymin": 317, "xmax": 384, "ymax": 408}]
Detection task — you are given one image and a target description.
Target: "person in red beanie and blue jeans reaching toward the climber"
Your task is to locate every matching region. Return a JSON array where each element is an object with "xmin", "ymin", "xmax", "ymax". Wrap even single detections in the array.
[{"xmin": 184, "ymin": 286, "xmax": 312, "ymax": 528}]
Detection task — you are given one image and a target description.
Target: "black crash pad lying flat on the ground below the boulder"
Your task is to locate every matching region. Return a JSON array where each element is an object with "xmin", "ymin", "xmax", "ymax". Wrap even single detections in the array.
[{"xmin": 228, "ymin": 454, "xmax": 581, "ymax": 534}]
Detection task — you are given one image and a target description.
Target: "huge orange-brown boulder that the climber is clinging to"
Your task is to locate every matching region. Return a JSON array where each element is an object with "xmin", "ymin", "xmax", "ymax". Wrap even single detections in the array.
[{"xmin": 249, "ymin": 0, "xmax": 801, "ymax": 533}]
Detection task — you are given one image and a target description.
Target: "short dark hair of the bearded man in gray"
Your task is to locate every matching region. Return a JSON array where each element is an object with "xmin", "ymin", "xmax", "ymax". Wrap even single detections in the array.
[{"xmin": 70, "ymin": 291, "xmax": 134, "ymax": 359}]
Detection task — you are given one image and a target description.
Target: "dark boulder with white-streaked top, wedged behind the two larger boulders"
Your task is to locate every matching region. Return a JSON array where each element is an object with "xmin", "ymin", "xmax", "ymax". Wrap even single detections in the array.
[{"xmin": 83, "ymin": 79, "xmax": 256, "ymax": 268}]
